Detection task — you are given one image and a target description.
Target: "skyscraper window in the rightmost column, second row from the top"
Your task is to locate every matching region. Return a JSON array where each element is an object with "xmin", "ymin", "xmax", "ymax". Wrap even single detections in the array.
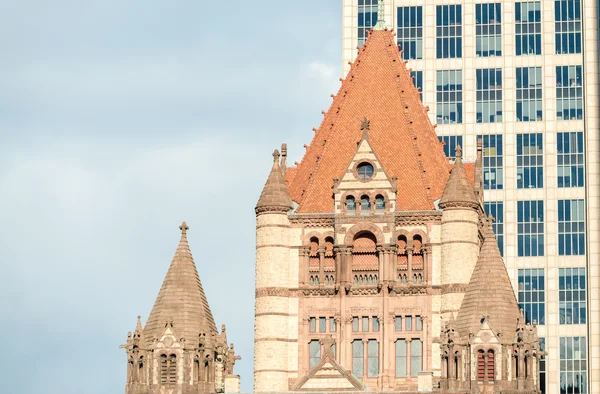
[{"xmin": 556, "ymin": 66, "xmax": 583, "ymax": 120}]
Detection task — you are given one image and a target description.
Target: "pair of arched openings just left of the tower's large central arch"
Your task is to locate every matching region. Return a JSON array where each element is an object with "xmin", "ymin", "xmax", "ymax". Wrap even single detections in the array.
[{"xmin": 307, "ymin": 236, "xmax": 335, "ymax": 286}]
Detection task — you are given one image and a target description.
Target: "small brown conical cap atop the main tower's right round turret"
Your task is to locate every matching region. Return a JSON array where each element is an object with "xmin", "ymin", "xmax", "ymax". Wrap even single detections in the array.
[{"xmin": 440, "ymin": 145, "xmax": 478, "ymax": 209}]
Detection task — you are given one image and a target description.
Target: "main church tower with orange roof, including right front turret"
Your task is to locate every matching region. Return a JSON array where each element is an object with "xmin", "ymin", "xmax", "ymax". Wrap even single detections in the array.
[{"xmin": 254, "ymin": 21, "xmax": 544, "ymax": 393}]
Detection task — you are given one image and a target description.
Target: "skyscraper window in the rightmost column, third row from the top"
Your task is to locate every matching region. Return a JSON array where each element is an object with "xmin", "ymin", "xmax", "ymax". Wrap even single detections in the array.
[{"xmin": 556, "ymin": 131, "xmax": 584, "ymax": 187}]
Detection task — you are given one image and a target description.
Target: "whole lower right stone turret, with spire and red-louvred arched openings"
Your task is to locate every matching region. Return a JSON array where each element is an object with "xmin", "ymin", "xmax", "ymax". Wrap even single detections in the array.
[{"xmin": 440, "ymin": 217, "xmax": 545, "ymax": 394}]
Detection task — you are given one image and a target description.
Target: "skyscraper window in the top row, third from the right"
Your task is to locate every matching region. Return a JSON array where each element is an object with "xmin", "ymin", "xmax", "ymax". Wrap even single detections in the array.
[{"xmin": 475, "ymin": 3, "xmax": 502, "ymax": 57}]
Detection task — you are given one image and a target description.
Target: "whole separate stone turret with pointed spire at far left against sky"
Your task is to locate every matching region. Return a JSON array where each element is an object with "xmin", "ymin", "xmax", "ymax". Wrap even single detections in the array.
[{"xmin": 121, "ymin": 222, "xmax": 240, "ymax": 394}]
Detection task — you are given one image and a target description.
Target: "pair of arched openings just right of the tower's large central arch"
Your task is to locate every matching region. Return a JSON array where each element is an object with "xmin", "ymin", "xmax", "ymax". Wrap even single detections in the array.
[{"xmin": 396, "ymin": 234, "xmax": 425, "ymax": 284}]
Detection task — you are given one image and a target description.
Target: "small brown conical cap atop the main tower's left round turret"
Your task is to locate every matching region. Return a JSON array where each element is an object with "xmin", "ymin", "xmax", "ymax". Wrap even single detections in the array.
[{"xmin": 255, "ymin": 149, "xmax": 292, "ymax": 214}]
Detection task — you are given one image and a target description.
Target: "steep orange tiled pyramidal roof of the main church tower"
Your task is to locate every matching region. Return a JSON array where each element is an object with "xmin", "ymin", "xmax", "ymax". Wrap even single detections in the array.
[{"xmin": 286, "ymin": 30, "xmax": 448, "ymax": 213}]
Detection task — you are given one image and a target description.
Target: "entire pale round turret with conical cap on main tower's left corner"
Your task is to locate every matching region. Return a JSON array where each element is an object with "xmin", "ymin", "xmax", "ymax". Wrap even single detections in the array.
[{"xmin": 254, "ymin": 150, "xmax": 298, "ymax": 392}]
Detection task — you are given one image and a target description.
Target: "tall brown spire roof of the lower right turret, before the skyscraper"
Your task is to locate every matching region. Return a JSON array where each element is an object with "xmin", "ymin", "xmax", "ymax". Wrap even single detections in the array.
[{"xmin": 455, "ymin": 217, "xmax": 520, "ymax": 341}]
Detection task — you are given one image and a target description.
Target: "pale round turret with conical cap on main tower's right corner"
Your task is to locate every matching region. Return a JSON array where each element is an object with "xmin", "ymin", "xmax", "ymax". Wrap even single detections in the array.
[{"xmin": 439, "ymin": 145, "xmax": 480, "ymax": 319}]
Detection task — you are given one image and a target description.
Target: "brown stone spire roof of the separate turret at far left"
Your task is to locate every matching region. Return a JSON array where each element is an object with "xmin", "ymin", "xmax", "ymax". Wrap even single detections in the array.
[{"xmin": 144, "ymin": 222, "xmax": 218, "ymax": 341}]
